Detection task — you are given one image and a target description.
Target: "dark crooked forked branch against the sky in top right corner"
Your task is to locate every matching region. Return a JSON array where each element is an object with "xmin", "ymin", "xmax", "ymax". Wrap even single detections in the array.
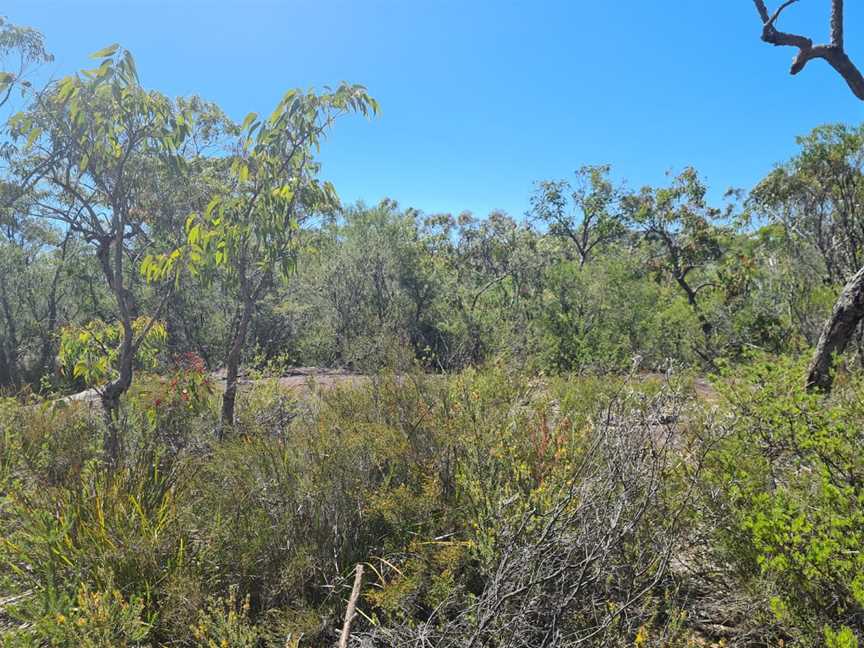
[{"xmin": 753, "ymin": 0, "xmax": 864, "ymax": 101}]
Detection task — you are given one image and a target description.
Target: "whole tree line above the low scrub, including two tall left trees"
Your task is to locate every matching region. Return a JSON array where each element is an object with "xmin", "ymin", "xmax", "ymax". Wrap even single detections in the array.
[{"xmin": 0, "ymin": 36, "xmax": 852, "ymax": 390}]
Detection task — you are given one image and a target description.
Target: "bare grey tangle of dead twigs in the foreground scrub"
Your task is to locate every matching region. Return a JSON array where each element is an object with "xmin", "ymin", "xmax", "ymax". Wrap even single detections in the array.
[{"xmin": 353, "ymin": 382, "xmax": 701, "ymax": 648}]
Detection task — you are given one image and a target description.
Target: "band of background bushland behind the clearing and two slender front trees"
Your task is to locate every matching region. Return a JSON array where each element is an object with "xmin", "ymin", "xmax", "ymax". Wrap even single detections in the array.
[{"xmin": 6, "ymin": 121, "xmax": 864, "ymax": 394}]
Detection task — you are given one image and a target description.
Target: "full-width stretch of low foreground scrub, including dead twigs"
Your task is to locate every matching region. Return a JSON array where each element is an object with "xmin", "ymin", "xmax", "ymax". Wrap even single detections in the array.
[{"xmin": 0, "ymin": 358, "xmax": 864, "ymax": 647}]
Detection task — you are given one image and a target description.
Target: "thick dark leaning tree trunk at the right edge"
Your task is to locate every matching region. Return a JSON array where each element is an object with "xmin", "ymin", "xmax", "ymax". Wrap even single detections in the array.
[{"xmin": 807, "ymin": 268, "xmax": 864, "ymax": 392}]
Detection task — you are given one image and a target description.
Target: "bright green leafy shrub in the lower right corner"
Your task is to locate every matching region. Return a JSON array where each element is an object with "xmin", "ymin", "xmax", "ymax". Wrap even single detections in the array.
[{"xmin": 711, "ymin": 359, "xmax": 864, "ymax": 645}]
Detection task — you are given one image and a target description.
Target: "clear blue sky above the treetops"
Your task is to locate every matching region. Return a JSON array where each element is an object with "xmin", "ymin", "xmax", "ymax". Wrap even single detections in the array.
[{"xmin": 2, "ymin": 0, "xmax": 864, "ymax": 216}]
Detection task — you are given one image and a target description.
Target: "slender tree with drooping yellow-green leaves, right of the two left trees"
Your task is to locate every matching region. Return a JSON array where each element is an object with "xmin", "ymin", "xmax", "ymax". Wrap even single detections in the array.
[{"xmin": 142, "ymin": 83, "xmax": 378, "ymax": 425}]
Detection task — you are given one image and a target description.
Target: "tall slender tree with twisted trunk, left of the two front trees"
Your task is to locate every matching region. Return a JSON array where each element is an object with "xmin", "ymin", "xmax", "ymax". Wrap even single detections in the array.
[{"xmin": 11, "ymin": 45, "xmax": 190, "ymax": 463}]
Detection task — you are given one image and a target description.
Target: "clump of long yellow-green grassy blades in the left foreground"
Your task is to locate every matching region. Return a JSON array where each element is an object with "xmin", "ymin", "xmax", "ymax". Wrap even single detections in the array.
[{"xmin": 0, "ymin": 442, "xmax": 194, "ymax": 634}]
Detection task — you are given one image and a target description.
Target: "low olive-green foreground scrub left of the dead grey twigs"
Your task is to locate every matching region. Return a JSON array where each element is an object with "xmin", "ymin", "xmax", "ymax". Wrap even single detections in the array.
[{"xmin": 0, "ymin": 366, "xmax": 708, "ymax": 646}]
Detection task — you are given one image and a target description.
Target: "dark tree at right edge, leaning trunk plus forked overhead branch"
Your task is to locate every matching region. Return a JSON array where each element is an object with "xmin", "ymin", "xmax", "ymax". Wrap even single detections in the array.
[{"xmin": 753, "ymin": 0, "xmax": 864, "ymax": 391}]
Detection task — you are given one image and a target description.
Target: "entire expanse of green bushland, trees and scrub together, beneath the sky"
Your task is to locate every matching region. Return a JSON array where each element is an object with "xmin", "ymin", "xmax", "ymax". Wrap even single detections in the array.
[{"xmin": 0, "ymin": 13, "xmax": 864, "ymax": 648}]
